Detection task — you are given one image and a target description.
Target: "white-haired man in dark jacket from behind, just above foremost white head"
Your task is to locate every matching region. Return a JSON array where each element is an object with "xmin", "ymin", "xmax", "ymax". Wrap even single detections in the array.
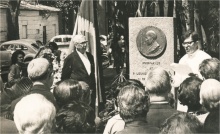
[{"xmin": 11, "ymin": 58, "xmax": 57, "ymax": 111}]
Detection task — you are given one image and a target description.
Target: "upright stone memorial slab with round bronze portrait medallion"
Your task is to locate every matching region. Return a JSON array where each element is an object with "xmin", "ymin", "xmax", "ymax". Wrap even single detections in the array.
[{"xmin": 129, "ymin": 17, "xmax": 174, "ymax": 84}]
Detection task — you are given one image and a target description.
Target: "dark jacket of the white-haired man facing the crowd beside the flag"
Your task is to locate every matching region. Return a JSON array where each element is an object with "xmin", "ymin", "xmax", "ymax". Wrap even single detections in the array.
[{"xmin": 61, "ymin": 51, "xmax": 95, "ymax": 89}]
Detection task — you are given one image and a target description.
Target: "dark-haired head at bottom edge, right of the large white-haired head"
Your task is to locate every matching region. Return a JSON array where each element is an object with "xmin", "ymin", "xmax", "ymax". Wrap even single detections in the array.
[{"xmin": 56, "ymin": 101, "xmax": 95, "ymax": 133}]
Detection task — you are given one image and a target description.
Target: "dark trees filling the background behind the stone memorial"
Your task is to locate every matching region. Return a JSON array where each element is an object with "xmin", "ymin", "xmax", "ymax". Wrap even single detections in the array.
[{"xmin": 107, "ymin": 0, "xmax": 220, "ymax": 58}]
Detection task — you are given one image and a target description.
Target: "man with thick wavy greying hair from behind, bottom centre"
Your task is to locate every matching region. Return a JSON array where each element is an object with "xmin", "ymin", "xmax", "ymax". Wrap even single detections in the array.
[{"xmin": 117, "ymin": 84, "xmax": 159, "ymax": 134}]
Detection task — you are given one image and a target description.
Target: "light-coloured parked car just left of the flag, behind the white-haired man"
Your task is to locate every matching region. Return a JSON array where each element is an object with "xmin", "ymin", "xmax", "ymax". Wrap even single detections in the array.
[{"xmin": 50, "ymin": 35, "xmax": 72, "ymax": 51}]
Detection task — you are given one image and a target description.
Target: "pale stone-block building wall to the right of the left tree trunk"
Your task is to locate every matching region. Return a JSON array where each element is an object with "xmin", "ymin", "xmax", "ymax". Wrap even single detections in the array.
[{"xmin": 19, "ymin": 10, "xmax": 59, "ymax": 42}]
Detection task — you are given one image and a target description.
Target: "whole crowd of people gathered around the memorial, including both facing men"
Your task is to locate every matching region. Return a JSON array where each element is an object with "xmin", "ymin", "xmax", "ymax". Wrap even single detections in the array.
[{"xmin": 0, "ymin": 32, "xmax": 220, "ymax": 134}]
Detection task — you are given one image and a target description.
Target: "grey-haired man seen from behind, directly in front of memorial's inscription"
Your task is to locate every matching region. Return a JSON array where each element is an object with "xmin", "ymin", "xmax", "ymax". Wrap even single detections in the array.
[{"xmin": 145, "ymin": 67, "xmax": 177, "ymax": 127}]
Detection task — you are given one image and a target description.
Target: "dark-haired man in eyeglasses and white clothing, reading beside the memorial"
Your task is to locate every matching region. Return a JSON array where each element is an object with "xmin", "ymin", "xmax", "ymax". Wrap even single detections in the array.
[{"xmin": 179, "ymin": 31, "xmax": 211, "ymax": 78}]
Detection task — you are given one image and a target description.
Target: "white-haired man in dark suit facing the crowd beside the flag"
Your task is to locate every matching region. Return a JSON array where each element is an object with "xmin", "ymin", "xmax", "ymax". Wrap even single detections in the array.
[{"xmin": 61, "ymin": 35, "xmax": 95, "ymax": 107}]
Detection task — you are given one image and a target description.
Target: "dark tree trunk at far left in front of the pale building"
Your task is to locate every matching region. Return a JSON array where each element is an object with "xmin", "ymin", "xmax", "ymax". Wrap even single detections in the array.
[{"xmin": 7, "ymin": 0, "xmax": 21, "ymax": 40}]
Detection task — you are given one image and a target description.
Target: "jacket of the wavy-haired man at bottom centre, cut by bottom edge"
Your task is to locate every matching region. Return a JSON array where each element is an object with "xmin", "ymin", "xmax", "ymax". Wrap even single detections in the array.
[{"xmin": 116, "ymin": 121, "xmax": 159, "ymax": 134}]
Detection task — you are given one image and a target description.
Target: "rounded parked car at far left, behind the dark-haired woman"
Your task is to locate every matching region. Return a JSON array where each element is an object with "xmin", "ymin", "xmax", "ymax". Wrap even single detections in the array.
[{"xmin": 0, "ymin": 39, "xmax": 43, "ymax": 81}]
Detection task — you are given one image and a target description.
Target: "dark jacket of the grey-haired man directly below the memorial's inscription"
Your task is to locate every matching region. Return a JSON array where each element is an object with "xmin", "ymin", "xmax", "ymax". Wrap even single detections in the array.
[{"xmin": 146, "ymin": 103, "xmax": 178, "ymax": 128}]
